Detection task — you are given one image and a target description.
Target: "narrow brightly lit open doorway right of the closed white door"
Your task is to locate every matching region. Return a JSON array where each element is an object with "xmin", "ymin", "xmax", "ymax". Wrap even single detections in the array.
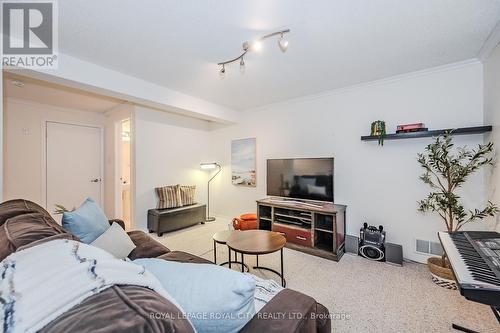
[{"xmin": 116, "ymin": 119, "xmax": 131, "ymax": 226}]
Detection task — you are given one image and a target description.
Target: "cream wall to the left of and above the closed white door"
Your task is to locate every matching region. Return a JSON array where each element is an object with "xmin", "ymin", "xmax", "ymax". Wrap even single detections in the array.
[{"xmin": 3, "ymin": 98, "xmax": 104, "ymax": 211}]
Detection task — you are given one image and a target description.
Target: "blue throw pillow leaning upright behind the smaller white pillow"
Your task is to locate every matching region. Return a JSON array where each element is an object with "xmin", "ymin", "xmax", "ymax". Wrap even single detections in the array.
[{"xmin": 62, "ymin": 198, "xmax": 109, "ymax": 244}]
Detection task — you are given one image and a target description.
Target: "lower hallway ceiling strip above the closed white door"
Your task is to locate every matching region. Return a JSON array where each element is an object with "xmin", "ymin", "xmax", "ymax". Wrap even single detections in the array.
[{"xmin": 3, "ymin": 72, "xmax": 124, "ymax": 113}]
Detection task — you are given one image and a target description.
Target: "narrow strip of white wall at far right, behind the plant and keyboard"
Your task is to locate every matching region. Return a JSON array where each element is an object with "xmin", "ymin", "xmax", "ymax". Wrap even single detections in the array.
[{"xmin": 484, "ymin": 44, "xmax": 500, "ymax": 232}]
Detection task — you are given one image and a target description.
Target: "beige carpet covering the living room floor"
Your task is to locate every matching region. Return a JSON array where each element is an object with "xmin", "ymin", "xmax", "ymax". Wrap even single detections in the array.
[{"xmin": 150, "ymin": 220, "xmax": 500, "ymax": 333}]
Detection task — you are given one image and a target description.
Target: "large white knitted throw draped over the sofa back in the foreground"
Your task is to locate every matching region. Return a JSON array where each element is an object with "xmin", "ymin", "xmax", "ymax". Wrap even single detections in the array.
[{"xmin": 0, "ymin": 240, "xmax": 188, "ymax": 333}]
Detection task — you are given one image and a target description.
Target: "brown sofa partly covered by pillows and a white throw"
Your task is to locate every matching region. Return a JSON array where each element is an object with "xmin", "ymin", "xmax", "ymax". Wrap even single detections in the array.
[{"xmin": 0, "ymin": 200, "xmax": 331, "ymax": 333}]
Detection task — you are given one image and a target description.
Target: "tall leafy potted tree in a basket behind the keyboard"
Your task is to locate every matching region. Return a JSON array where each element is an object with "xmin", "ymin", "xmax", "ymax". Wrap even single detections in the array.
[{"xmin": 418, "ymin": 133, "xmax": 498, "ymax": 289}]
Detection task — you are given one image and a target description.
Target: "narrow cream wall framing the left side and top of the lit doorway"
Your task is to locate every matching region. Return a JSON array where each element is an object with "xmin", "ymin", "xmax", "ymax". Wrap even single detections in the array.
[{"xmin": 104, "ymin": 103, "xmax": 134, "ymax": 218}]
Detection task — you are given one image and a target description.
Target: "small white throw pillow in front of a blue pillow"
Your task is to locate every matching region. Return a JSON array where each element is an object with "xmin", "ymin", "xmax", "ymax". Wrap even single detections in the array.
[{"xmin": 90, "ymin": 223, "xmax": 135, "ymax": 259}]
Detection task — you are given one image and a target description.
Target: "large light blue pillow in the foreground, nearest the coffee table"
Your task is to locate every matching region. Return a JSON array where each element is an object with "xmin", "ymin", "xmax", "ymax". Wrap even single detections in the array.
[{"xmin": 133, "ymin": 258, "xmax": 255, "ymax": 333}]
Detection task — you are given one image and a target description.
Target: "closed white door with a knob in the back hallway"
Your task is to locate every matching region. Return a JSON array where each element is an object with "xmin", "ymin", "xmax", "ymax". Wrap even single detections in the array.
[{"xmin": 46, "ymin": 122, "xmax": 103, "ymax": 213}]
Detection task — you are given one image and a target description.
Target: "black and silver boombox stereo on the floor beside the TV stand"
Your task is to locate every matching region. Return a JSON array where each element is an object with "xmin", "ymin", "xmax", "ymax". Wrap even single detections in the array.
[{"xmin": 359, "ymin": 223, "xmax": 385, "ymax": 261}]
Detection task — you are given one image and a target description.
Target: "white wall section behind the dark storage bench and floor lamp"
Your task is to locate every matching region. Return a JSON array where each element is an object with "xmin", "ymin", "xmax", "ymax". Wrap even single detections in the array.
[{"xmin": 132, "ymin": 106, "xmax": 210, "ymax": 230}]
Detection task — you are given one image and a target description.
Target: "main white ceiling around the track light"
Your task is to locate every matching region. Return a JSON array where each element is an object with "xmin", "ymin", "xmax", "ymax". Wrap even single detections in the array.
[{"xmin": 59, "ymin": 0, "xmax": 500, "ymax": 110}]
